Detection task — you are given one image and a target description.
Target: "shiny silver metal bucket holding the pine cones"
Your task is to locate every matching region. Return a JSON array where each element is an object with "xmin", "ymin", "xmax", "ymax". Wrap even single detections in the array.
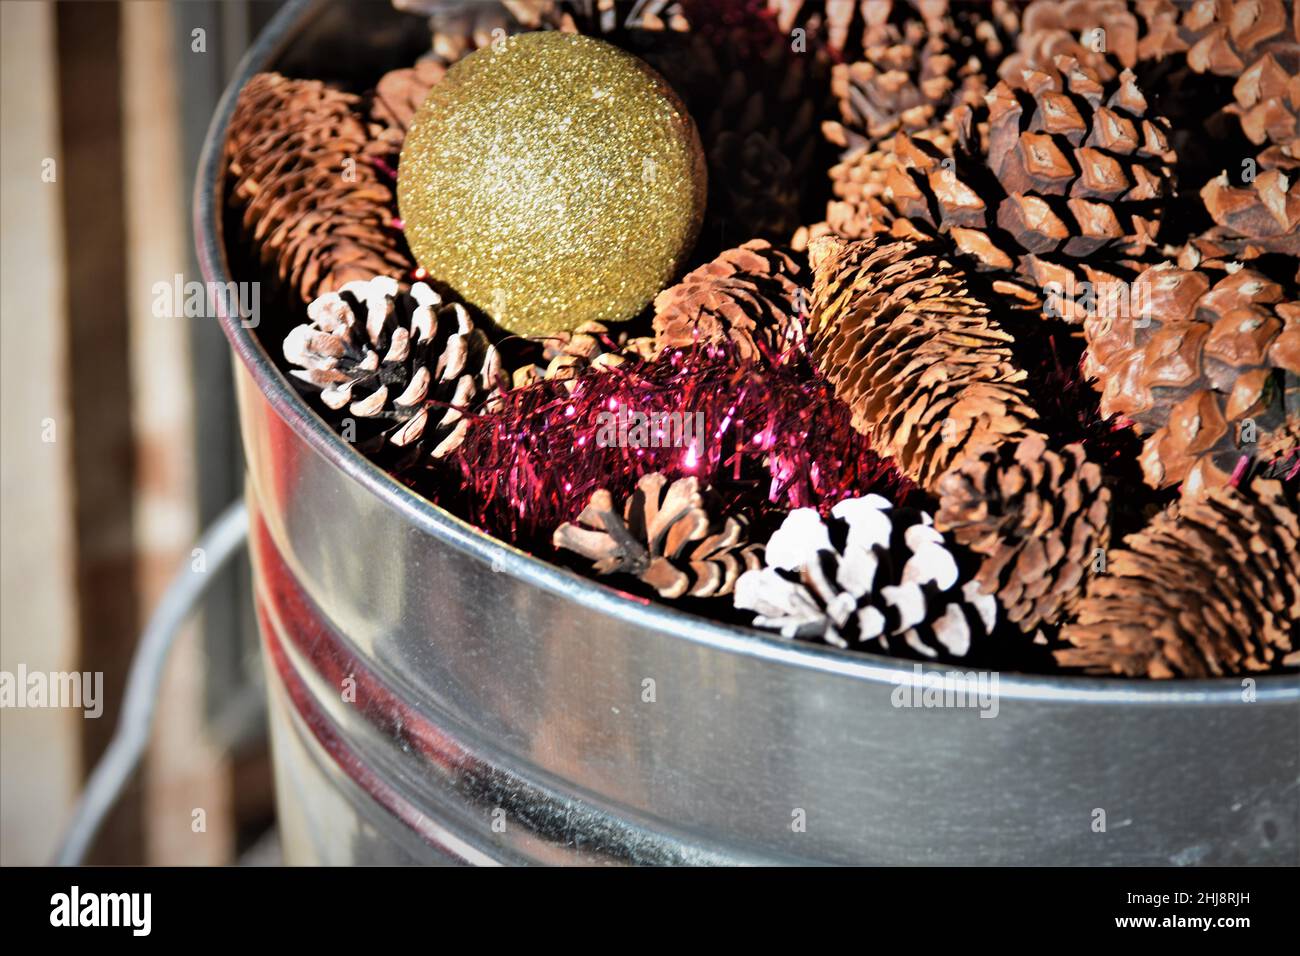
[{"xmin": 195, "ymin": 0, "xmax": 1300, "ymax": 864}]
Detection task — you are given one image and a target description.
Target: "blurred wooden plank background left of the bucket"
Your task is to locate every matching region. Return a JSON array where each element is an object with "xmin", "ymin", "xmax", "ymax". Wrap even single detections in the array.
[{"xmin": 0, "ymin": 0, "xmax": 277, "ymax": 865}]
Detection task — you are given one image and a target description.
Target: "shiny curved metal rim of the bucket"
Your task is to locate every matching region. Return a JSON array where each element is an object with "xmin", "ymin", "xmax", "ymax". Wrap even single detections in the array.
[{"xmin": 192, "ymin": 0, "xmax": 1300, "ymax": 706}]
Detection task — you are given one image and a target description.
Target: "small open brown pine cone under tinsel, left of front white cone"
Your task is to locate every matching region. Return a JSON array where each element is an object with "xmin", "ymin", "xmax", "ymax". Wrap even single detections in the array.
[{"xmin": 553, "ymin": 472, "xmax": 761, "ymax": 600}]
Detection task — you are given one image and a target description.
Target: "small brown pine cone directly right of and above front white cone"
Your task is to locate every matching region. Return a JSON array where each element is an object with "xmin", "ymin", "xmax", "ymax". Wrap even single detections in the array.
[{"xmin": 935, "ymin": 434, "xmax": 1110, "ymax": 633}]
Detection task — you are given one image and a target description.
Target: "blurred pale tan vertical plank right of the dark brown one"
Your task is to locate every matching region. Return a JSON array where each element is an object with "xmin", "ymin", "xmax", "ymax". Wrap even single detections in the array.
[{"xmin": 122, "ymin": 3, "xmax": 234, "ymax": 865}]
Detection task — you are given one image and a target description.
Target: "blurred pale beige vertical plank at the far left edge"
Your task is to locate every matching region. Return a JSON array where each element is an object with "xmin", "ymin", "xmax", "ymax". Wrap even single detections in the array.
[{"xmin": 0, "ymin": 3, "xmax": 81, "ymax": 866}]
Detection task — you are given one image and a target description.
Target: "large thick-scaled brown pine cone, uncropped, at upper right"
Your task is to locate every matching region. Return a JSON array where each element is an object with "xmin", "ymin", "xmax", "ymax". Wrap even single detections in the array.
[{"xmin": 889, "ymin": 57, "xmax": 1174, "ymax": 286}]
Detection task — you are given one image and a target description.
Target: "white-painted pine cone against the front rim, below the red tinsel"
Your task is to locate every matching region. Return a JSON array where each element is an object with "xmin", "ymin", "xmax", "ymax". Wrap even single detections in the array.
[{"xmin": 736, "ymin": 494, "xmax": 997, "ymax": 658}]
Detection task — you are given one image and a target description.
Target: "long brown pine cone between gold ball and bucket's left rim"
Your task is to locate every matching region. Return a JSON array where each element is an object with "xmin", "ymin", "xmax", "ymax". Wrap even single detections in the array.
[{"xmin": 226, "ymin": 73, "xmax": 413, "ymax": 303}]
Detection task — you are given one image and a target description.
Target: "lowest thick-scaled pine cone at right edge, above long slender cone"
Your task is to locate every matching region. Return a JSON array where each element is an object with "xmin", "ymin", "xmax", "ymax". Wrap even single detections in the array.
[{"xmin": 1084, "ymin": 264, "xmax": 1300, "ymax": 494}]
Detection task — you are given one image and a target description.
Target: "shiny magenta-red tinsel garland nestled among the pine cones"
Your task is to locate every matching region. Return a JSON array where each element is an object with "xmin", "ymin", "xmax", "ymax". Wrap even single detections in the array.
[{"xmin": 420, "ymin": 349, "xmax": 914, "ymax": 546}]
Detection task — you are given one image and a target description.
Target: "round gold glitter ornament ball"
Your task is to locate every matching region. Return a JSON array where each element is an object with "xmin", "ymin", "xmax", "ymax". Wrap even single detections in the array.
[{"xmin": 398, "ymin": 31, "xmax": 707, "ymax": 336}]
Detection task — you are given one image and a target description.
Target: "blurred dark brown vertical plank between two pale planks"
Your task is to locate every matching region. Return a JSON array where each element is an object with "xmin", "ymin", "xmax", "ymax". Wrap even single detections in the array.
[{"xmin": 55, "ymin": 1, "xmax": 142, "ymax": 864}]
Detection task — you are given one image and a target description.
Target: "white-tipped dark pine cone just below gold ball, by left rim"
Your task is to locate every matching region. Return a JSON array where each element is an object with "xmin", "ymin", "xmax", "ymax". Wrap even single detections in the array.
[{"xmin": 283, "ymin": 276, "xmax": 506, "ymax": 464}]
